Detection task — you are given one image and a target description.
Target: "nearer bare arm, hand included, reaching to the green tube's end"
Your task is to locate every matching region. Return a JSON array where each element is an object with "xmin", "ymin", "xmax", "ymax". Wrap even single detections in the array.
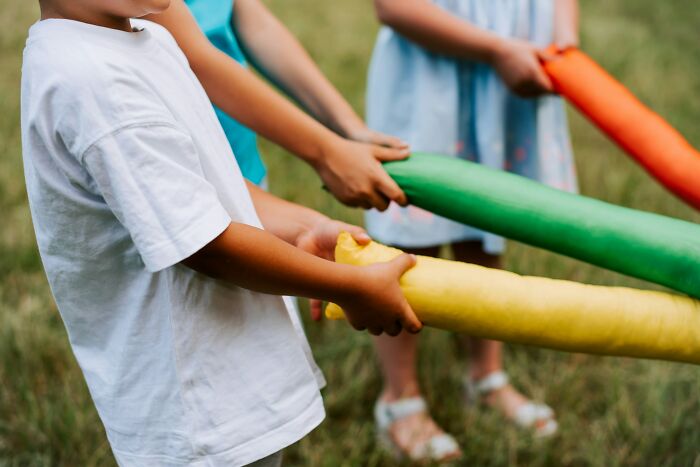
[{"xmin": 148, "ymin": 0, "xmax": 409, "ymax": 210}]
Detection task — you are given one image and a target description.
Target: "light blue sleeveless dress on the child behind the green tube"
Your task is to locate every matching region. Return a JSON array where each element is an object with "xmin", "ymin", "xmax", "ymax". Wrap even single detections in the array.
[{"xmin": 366, "ymin": 0, "xmax": 577, "ymax": 254}]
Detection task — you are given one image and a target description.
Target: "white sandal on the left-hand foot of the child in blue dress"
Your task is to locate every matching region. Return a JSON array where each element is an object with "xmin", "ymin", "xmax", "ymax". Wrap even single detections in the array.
[{"xmin": 374, "ymin": 397, "xmax": 460, "ymax": 462}]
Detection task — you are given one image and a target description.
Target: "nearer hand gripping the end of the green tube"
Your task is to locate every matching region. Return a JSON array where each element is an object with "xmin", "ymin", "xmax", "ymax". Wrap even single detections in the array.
[{"xmin": 316, "ymin": 138, "xmax": 409, "ymax": 211}]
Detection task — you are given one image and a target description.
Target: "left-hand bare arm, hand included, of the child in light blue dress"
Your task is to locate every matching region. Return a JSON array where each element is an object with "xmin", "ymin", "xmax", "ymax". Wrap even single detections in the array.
[{"xmin": 374, "ymin": 0, "xmax": 552, "ymax": 97}]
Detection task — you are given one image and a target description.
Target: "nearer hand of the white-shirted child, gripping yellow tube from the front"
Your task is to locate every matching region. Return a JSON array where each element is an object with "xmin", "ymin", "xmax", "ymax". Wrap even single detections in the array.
[{"xmin": 338, "ymin": 254, "xmax": 423, "ymax": 336}]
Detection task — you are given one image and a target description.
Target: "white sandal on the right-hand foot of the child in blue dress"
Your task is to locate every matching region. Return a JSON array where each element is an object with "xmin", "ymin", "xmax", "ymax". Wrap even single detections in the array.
[{"xmin": 464, "ymin": 371, "xmax": 559, "ymax": 438}]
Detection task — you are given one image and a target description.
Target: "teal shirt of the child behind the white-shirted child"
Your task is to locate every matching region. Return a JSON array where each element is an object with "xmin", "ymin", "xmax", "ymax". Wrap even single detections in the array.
[{"xmin": 185, "ymin": 0, "xmax": 266, "ymax": 185}]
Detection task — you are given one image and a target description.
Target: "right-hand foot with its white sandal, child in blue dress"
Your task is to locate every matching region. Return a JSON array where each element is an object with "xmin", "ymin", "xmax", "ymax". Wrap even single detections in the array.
[{"xmin": 464, "ymin": 371, "xmax": 558, "ymax": 438}]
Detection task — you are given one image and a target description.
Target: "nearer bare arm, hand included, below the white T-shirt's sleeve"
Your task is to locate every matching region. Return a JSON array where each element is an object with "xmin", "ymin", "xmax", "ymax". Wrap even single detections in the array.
[{"xmin": 183, "ymin": 223, "xmax": 422, "ymax": 335}]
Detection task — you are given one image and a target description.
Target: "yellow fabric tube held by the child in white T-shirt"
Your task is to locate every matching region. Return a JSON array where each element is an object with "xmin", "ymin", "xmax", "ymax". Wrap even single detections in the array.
[{"xmin": 326, "ymin": 233, "xmax": 700, "ymax": 364}]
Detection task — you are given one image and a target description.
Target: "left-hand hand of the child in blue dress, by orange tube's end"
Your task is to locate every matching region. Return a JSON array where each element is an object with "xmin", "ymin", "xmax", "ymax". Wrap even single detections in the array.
[{"xmin": 492, "ymin": 39, "xmax": 554, "ymax": 97}]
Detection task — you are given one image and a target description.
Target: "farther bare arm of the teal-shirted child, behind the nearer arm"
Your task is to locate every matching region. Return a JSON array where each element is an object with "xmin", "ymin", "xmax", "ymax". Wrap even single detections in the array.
[{"xmin": 233, "ymin": 0, "xmax": 405, "ymax": 148}]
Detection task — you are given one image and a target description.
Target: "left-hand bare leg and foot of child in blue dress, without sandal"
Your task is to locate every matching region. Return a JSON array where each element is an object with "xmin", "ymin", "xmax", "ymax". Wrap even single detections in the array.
[{"xmin": 374, "ymin": 248, "xmax": 461, "ymax": 458}]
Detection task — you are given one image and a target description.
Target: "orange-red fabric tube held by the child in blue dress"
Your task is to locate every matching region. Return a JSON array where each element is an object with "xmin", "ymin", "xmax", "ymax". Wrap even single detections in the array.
[{"xmin": 543, "ymin": 47, "xmax": 700, "ymax": 209}]
